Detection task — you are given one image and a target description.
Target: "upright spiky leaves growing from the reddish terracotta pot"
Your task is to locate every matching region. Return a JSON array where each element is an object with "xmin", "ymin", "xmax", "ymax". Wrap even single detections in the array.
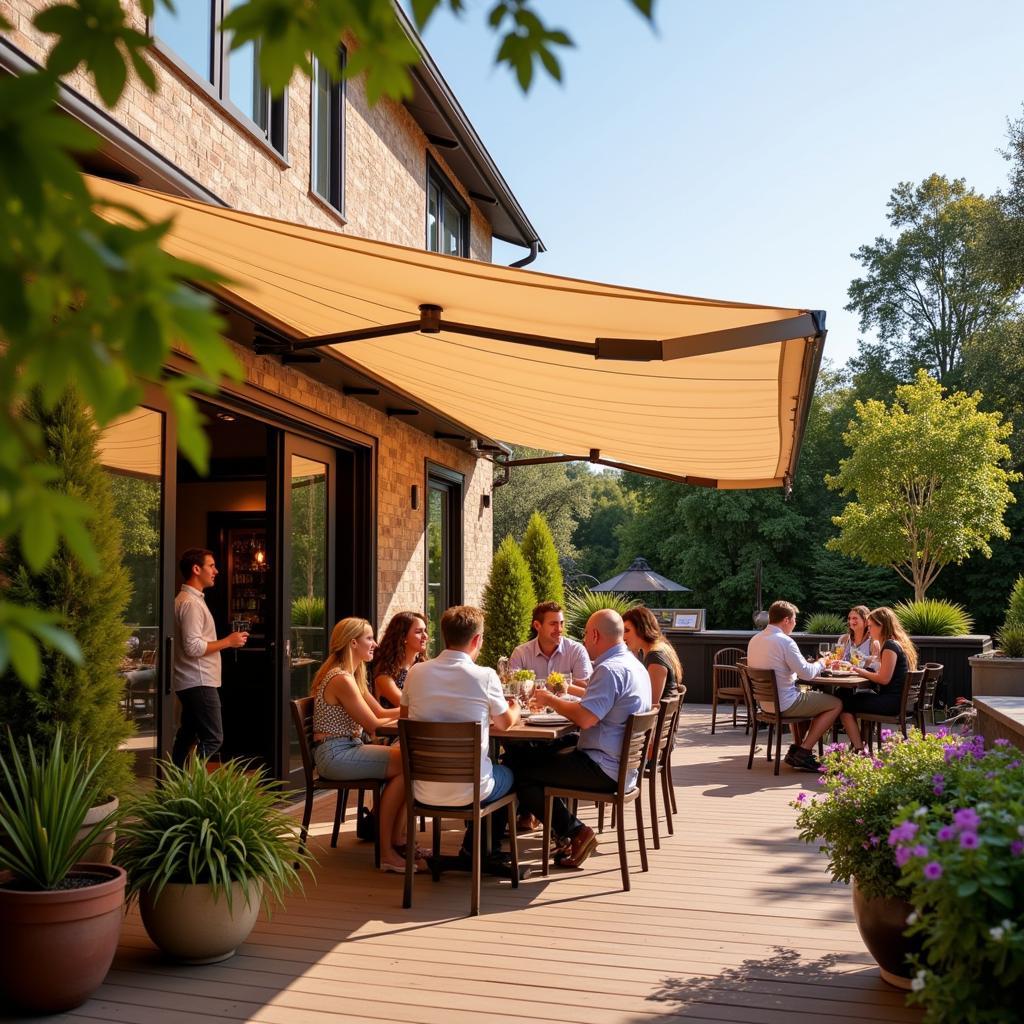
[{"xmin": 0, "ymin": 728, "xmax": 117, "ymax": 890}]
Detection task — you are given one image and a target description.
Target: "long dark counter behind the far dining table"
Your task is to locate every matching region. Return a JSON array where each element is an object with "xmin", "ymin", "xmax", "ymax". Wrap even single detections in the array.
[{"xmin": 665, "ymin": 629, "xmax": 992, "ymax": 705}]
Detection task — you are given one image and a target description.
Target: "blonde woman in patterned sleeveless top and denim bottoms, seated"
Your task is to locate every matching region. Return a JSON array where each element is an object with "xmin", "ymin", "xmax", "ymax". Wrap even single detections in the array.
[{"xmin": 311, "ymin": 618, "xmax": 419, "ymax": 871}]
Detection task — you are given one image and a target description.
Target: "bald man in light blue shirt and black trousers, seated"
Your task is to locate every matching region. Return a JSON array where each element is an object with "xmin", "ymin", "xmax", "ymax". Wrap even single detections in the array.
[{"xmin": 512, "ymin": 608, "xmax": 650, "ymax": 867}]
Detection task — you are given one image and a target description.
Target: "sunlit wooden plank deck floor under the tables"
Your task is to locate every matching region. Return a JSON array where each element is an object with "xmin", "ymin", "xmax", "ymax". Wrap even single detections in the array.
[{"xmin": 28, "ymin": 708, "xmax": 920, "ymax": 1024}]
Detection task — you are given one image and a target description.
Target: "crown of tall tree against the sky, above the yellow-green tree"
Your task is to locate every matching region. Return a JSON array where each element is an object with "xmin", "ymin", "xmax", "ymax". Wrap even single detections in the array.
[{"xmin": 846, "ymin": 174, "xmax": 1017, "ymax": 383}]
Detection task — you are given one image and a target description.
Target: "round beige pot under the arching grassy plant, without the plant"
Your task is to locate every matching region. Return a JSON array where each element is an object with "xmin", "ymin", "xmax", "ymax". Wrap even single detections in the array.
[{"xmin": 138, "ymin": 882, "xmax": 263, "ymax": 964}]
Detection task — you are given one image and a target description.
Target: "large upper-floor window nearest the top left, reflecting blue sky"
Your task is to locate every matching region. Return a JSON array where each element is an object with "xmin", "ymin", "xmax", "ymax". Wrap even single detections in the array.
[{"xmin": 150, "ymin": 0, "xmax": 286, "ymax": 155}]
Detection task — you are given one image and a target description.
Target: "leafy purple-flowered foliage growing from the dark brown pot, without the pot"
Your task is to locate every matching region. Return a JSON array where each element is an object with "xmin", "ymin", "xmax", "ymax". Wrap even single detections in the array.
[{"xmin": 791, "ymin": 731, "xmax": 955, "ymax": 898}]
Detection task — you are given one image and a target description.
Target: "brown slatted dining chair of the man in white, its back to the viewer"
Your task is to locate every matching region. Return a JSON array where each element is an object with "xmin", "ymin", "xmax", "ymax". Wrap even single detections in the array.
[{"xmin": 398, "ymin": 718, "xmax": 519, "ymax": 916}]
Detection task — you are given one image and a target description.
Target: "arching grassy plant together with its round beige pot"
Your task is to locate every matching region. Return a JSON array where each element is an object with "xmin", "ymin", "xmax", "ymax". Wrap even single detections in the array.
[{"xmin": 117, "ymin": 758, "xmax": 310, "ymax": 964}]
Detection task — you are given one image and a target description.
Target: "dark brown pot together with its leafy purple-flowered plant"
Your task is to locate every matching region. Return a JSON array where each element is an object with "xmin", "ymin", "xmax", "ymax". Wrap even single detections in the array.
[{"xmin": 793, "ymin": 731, "xmax": 956, "ymax": 988}]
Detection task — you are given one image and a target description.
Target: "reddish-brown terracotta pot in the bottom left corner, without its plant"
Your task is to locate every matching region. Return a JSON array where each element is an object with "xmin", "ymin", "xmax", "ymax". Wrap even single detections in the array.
[{"xmin": 0, "ymin": 863, "xmax": 127, "ymax": 1014}]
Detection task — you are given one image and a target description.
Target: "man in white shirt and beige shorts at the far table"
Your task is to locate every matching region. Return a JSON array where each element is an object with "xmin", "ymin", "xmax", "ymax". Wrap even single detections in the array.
[{"xmin": 746, "ymin": 601, "xmax": 843, "ymax": 771}]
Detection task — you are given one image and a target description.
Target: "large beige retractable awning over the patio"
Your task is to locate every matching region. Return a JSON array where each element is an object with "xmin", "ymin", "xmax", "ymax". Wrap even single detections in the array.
[{"xmin": 91, "ymin": 179, "xmax": 824, "ymax": 487}]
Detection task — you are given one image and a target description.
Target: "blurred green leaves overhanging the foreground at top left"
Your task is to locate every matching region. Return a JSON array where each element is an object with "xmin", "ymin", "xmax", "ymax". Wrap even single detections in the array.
[{"xmin": 0, "ymin": 0, "xmax": 653, "ymax": 685}]
